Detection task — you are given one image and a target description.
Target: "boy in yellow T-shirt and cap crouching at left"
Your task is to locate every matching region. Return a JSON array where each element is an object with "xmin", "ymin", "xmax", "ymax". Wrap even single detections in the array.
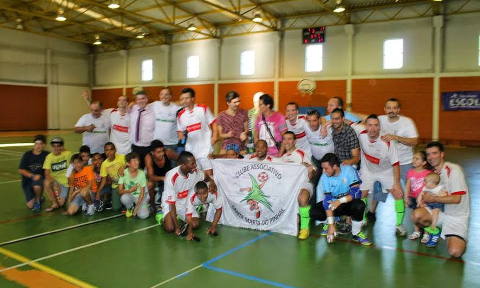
[{"xmin": 43, "ymin": 137, "xmax": 72, "ymax": 212}]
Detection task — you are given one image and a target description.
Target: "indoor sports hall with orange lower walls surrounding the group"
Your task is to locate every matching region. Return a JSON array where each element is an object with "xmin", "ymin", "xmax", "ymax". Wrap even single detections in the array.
[{"xmin": 0, "ymin": 0, "xmax": 480, "ymax": 288}]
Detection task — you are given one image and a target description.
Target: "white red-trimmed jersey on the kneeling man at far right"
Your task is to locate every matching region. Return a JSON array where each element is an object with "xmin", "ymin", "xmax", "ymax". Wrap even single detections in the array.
[{"xmin": 440, "ymin": 162, "xmax": 470, "ymax": 219}]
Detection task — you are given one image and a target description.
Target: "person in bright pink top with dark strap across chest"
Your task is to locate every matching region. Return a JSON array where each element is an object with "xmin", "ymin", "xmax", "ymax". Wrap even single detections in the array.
[{"xmin": 253, "ymin": 94, "xmax": 287, "ymax": 156}]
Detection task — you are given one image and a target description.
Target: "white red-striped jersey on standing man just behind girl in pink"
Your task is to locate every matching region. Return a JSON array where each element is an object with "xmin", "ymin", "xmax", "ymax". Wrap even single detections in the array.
[{"xmin": 358, "ymin": 130, "xmax": 399, "ymax": 173}]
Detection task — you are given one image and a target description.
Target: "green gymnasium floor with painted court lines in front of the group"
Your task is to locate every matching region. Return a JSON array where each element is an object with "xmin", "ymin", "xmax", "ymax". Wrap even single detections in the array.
[{"xmin": 0, "ymin": 131, "xmax": 480, "ymax": 288}]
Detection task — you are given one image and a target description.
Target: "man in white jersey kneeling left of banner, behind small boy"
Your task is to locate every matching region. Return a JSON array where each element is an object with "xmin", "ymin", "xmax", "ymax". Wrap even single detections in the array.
[{"xmin": 156, "ymin": 151, "xmax": 217, "ymax": 238}]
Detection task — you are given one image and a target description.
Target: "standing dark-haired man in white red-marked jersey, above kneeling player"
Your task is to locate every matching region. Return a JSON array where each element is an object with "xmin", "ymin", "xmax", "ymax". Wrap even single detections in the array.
[{"xmin": 177, "ymin": 88, "xmax": 217, "ymax": 176}]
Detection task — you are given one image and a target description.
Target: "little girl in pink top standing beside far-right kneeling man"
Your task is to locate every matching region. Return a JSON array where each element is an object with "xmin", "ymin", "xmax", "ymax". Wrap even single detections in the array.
[{"xmin": 404, "ymin": 151, "xmax": 432, "ymax": 240}]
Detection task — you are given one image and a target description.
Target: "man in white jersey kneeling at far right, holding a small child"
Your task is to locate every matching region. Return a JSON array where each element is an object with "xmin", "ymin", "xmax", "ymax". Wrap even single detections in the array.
[{"xmin": 410, "ymin": 141, "xmax": 470, "ymax": 258}]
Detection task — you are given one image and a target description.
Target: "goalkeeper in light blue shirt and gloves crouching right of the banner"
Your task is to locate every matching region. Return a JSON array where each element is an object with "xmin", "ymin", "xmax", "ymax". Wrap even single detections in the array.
[{"xmin": 310, "ymin": 153, "xmax": 372, "ymax": 245}]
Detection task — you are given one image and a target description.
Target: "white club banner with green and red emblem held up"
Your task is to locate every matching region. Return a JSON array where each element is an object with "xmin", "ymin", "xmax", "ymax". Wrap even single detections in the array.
[{"xmin": 207, "ymin": 159, "xmax": 308, "ymax": 236}]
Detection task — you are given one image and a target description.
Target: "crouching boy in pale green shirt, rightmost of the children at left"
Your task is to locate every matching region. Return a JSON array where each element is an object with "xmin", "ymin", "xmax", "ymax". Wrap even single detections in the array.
[{"xmin": 118, "ymin": 152, "xmax": 150, "ymax": 219}]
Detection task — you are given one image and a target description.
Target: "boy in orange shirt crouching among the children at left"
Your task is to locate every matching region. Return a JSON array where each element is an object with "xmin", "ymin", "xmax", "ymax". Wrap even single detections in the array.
[{"xmin": 67, "ymin": 153, "xmax": 97, "ymax": 216}]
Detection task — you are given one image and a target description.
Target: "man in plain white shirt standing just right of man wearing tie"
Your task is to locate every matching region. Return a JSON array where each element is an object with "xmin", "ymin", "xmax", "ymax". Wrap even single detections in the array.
[{"xmin": 154, "ymin": 87, "xmax": 182, "ymax": 152}]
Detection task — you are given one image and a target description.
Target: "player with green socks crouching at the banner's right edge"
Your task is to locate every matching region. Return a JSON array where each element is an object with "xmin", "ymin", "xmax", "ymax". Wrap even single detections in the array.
[{"xmin": 280, "ymin": 131, "xmax": 316, "ymax": 240}]
